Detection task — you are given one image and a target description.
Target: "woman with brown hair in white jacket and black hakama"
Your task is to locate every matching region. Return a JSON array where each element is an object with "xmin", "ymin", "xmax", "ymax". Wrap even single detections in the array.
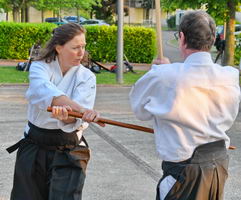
[{"xmin": 8, "ymin": 23, "xmax": 104, "ymax": 200}]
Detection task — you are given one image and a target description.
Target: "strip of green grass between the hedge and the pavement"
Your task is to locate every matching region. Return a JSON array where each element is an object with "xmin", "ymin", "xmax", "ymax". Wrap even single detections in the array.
[{"xmin": 0, "ymin": 67, "xmax": 146, "ymax": 85}]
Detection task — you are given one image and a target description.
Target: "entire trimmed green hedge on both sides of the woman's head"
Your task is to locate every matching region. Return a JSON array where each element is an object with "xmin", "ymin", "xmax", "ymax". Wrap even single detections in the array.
[{"xmin": 0, "ymin": 22, "xmax": 156, "ymax": 63}]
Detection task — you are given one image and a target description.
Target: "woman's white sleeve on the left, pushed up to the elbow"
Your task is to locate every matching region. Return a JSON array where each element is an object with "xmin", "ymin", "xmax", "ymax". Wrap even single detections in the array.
[{"xmin": 26, "ymin": 62, "xmax": 65, "ymax": 110}]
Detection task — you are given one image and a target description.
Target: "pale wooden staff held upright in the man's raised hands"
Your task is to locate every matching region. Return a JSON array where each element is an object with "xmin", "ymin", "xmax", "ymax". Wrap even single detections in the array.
[{"xmin": 155, "ymin": 0, "xmax": 163, "ymax": 59}]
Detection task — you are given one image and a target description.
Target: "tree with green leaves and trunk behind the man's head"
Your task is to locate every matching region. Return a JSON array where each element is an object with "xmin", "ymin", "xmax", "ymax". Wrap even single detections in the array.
[{"xmin": 161, "ymin": 0, "xmax": 241, "ymax": 65}]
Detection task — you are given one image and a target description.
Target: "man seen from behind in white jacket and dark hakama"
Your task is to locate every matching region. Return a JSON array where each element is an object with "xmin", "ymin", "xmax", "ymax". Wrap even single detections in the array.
[{"xmin": 130, "ymin": 11, "xmax": 240, "ymax": 200}]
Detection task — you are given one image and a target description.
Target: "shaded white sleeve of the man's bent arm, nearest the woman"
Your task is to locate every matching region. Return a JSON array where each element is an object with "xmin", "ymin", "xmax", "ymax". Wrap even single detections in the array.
[{"xmin": 129, "ymin": 67, "xmax": 157, "ymax": 120}]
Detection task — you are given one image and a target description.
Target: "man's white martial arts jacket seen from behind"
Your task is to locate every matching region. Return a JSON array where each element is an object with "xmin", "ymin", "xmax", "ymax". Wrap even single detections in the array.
[{"xmin": 130, "ymin": 52, "xmax": 240, "ymax": 162}]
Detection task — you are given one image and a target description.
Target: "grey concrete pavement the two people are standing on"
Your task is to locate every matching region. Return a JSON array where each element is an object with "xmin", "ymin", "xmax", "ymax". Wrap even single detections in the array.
[{"xmin": 0, "ymin": 86, "xmax": 241, "ymax": 200}]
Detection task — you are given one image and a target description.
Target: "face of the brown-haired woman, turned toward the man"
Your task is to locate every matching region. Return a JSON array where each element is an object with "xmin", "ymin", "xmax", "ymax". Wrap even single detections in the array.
[{"xmin": 56, "ymin": 34, "xmax": 86, "ymax": 72}]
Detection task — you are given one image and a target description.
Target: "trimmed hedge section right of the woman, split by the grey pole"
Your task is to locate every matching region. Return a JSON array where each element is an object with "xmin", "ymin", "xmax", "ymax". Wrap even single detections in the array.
[{"xmin": 86, "ymin": 26, "xmax": 156, "ymax": 63}]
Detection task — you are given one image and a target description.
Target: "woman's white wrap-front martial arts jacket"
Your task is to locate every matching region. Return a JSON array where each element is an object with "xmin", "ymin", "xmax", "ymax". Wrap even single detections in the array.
[{"xmin": 25, "ymin": 59, "xmax": 96, "ymax": 132}]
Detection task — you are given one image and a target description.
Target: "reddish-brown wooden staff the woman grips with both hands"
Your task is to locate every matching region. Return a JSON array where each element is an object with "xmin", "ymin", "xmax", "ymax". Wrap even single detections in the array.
[{"xmin": 47, "ymin": 107, "xmax": 154, "ymax": 133}]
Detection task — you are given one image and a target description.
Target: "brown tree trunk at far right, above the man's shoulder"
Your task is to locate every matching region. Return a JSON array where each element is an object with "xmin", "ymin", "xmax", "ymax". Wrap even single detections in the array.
[{"xmin": 222, "ymin": 0, "xmax": 236, "ymax": 66}]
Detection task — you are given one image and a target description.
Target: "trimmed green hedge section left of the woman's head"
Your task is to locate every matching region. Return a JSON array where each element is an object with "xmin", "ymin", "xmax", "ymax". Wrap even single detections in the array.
[{"xmin": 0, "ymin": 22, "xmax": 56, "ymax": 59}]
